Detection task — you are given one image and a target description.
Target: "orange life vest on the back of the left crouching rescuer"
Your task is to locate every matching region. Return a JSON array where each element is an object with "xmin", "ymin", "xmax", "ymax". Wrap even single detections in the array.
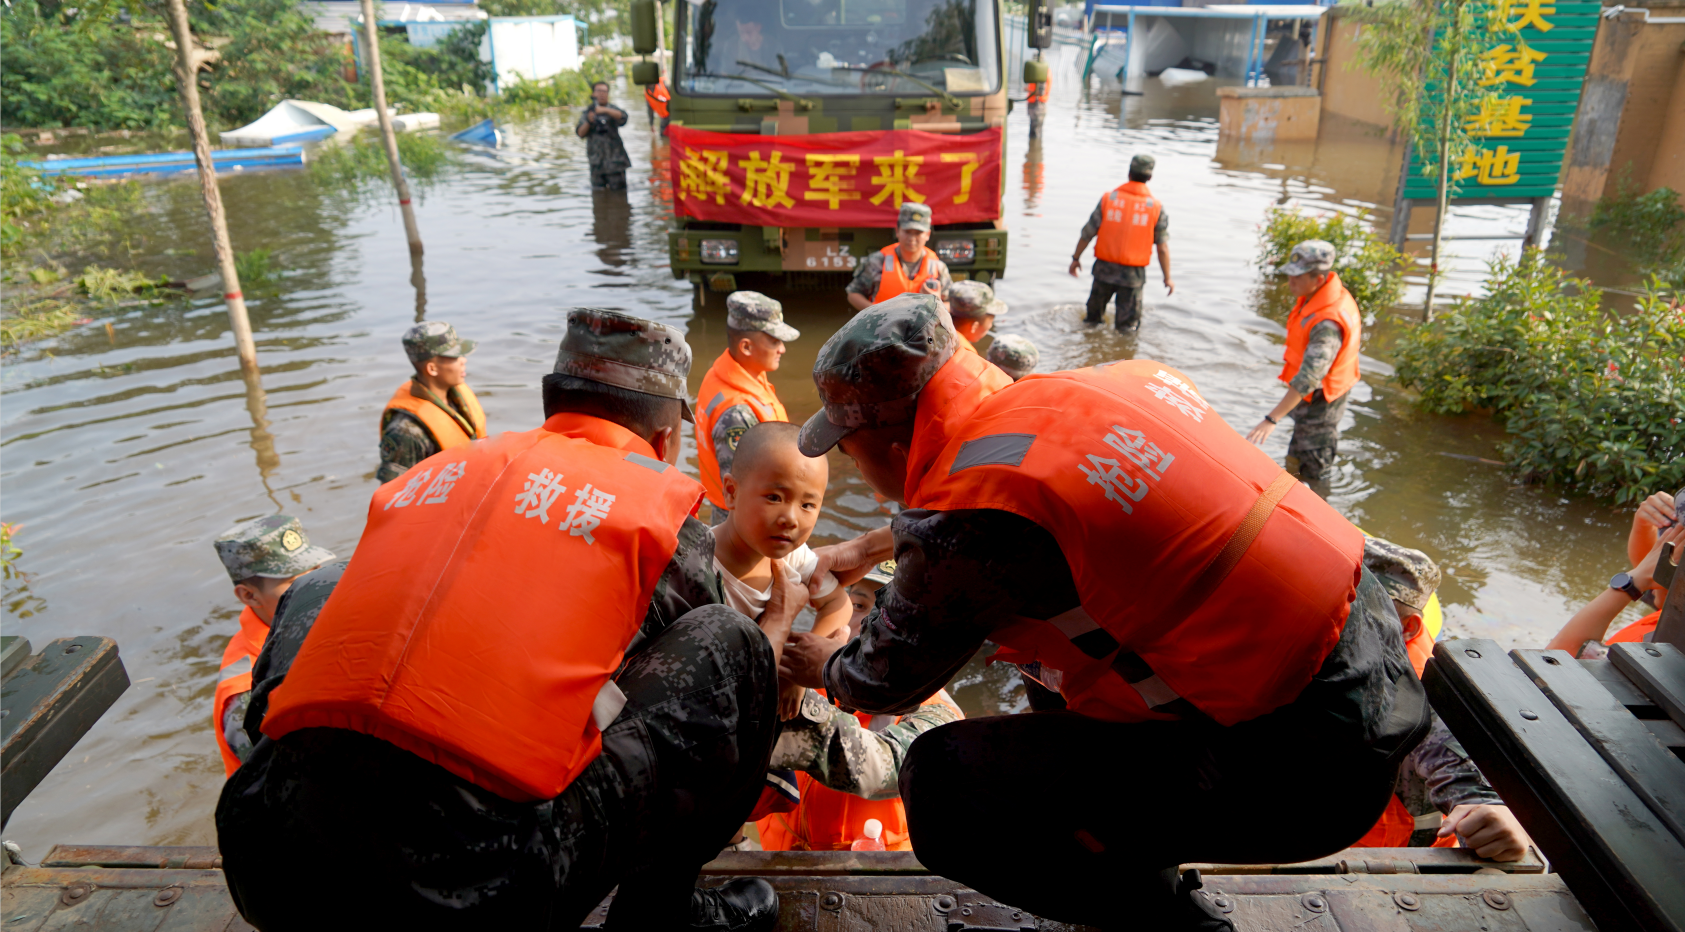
[{"xmin": 263, "ymin": 413, "xmax": 703, "ymax": 799}]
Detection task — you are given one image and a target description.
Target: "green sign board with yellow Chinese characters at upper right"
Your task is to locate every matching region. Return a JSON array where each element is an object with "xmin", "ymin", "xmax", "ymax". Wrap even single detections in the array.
[{"xmin": 1404, "ymin": 0, "xmax": 1602, "ymax": 201}]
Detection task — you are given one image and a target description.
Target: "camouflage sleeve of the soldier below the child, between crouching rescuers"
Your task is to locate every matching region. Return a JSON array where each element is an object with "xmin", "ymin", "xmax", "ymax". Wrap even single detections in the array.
[{"xmin": 772, "ymin": 689, "xmax": 959, "ymax": 799}]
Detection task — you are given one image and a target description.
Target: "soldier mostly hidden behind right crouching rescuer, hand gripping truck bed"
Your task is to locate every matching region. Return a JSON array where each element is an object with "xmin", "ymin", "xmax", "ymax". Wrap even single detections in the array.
[{"xmin": 1358, "ymin": 538, "xmax": 1530, "ymax": 861}]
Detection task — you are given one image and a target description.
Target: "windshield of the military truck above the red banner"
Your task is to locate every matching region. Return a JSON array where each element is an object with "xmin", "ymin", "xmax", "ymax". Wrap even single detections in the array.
[{"xmin": 677, "ymin": 0, "xmax": 1001, "ymax": 98}]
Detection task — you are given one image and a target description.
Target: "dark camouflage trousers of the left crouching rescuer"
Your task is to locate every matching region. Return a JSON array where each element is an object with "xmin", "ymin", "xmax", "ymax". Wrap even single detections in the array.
[{"xmin": 216, "ymin": 605, "xmax": 778, "ymax": 929}]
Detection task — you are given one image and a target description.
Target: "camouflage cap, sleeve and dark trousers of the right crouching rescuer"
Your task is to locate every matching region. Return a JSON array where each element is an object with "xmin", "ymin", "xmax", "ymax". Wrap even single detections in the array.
[{"xmin": 800, "ymin": 295, "xmax": 1427, "ymax": 929}]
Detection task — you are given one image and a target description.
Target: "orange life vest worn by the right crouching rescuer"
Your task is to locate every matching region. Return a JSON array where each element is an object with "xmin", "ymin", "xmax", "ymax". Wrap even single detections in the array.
[{"xmin": 907, "ymin": 354, "xmax": 1363, "ymax": 725}]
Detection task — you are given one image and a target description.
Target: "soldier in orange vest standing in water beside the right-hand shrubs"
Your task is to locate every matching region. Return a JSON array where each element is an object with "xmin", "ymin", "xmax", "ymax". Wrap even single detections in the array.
[{"xmin": 1247, "ymin": 239, "xmax": 1361, "ymax": 482}]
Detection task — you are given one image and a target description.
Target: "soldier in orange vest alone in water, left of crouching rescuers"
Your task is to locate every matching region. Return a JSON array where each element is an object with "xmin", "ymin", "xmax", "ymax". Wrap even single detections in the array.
[{"xmin": 374, "ymin": 320, "xmax": 485, "ymax": 482}]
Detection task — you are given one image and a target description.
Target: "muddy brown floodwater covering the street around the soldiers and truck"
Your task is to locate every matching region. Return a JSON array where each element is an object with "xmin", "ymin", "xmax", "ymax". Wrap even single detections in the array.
[{"xmin": 0, "ymin": 69, "xmax": 1636, "ymax": 860}]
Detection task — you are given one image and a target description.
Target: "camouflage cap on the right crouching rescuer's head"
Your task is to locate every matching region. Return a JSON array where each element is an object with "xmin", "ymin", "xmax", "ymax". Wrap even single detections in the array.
[{"xmin": 799, "ymin": 293, "xmax": 957, "ymax": 457}]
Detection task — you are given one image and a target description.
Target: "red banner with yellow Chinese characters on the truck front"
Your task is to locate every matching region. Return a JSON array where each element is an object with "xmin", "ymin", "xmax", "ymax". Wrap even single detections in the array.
[{"xmin": 667, "ymin": 126, "xmax": 1001, "ymax": 228}]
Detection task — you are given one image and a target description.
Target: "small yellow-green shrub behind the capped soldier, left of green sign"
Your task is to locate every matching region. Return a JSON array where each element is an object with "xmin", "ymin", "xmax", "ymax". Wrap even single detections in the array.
[{"xmin": 1259, "ymin": 207, "xmax": 1404, "ymax": 313}]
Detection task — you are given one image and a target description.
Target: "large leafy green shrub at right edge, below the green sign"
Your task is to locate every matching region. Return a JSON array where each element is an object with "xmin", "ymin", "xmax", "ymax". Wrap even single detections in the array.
[{"xmin": 1397, "ymin": 249, "xmax": 1685, "ymax": 504}]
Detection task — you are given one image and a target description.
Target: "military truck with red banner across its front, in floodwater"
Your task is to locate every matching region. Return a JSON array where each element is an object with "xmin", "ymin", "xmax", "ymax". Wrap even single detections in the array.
[{"xmin": 632, "ymin": 0, "xmax": 1051, "ymax": 293}]
